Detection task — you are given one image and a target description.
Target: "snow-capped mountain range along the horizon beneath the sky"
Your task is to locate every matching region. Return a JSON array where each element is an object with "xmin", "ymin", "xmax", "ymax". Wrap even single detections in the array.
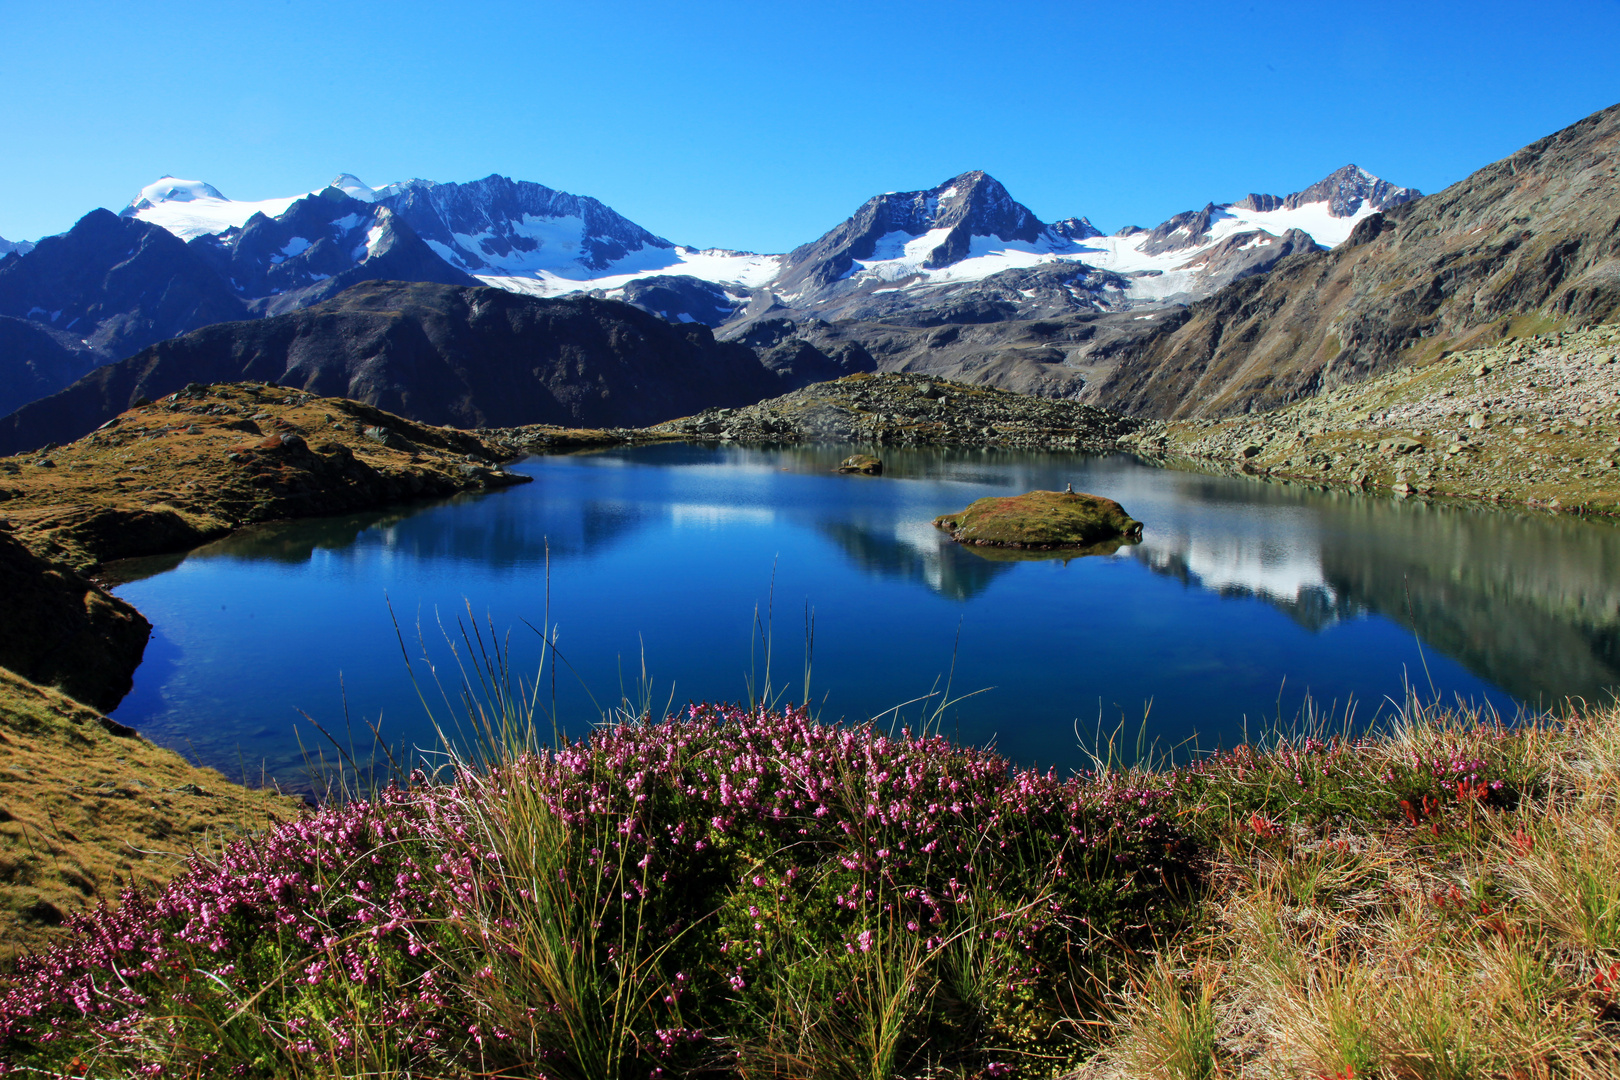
[{"xmin": 0, "ymin": 165, "xmax": 1418, "ymax": 420}]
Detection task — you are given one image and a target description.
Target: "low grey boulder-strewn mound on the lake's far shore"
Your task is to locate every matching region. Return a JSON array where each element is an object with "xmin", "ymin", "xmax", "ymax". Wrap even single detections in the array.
[{"xmin": 648, "ymin": 374, "xmax": 1140, "ymax": 452}]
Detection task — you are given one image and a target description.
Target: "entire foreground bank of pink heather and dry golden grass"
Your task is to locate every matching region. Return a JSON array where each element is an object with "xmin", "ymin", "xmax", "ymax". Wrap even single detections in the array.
[{"xmin": 0, "ymin": 689, "xmax": 1620, "ymax": 1080}]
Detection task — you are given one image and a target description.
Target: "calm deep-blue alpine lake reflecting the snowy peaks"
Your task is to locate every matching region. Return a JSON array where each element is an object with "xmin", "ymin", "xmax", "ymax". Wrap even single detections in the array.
[{"xmin": 115, "ymin": 445, "xmax": 1620, "ymax": 787}]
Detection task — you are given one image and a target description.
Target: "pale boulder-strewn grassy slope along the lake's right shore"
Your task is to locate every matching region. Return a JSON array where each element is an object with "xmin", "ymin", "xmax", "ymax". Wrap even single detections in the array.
[{"xmin": 1124, "ymin": 324, "xmax": 1620, "ymax": 513}]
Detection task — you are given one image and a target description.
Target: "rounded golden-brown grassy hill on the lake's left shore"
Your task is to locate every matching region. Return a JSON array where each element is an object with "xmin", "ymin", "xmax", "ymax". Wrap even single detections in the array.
[{"xmin": 0, "ymin": 382, "xmax": 527, "ymax": 572}]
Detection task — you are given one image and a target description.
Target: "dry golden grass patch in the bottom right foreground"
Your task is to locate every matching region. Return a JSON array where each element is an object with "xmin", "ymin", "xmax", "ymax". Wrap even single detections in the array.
[{"xmin": 1085, "ymin": 708, "xmax": 1620, "ymax": 1080}]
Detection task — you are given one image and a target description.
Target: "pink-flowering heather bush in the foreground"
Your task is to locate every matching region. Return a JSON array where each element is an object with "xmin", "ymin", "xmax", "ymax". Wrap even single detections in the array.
[{"xmin": 0, "ymin": 706, "xmax": 1192, "ymax": 1077}]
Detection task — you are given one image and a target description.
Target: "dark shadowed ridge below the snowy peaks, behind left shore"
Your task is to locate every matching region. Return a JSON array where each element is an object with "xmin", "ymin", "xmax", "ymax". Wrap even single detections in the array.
[{"xmin": 0, "ymin": 282, "xmax": 787, "ymax": 453}]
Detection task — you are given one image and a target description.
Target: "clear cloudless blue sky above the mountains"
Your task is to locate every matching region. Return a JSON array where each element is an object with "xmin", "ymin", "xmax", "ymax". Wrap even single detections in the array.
[{"xmin": 0, "ymin": 0, "xmax": 1620, "ymax": 251}]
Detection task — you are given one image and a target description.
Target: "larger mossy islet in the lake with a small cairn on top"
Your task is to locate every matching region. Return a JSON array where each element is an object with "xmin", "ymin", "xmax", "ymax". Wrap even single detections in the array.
[{"xmin": 933, "ymin": 491, "xmax": 1142, "ymax": 551}]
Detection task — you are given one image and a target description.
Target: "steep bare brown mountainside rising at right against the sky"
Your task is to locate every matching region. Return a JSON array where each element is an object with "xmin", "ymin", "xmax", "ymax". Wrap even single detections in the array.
[{"xmin": 1087, "ymin": 105, "xmax": 1620, "ymax": 416}]
